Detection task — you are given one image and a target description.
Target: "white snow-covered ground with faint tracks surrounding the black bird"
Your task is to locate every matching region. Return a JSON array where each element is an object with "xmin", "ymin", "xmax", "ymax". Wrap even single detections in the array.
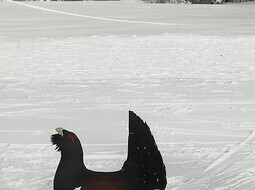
[{"xmin": 0, "ymin": 2, "xmax": 255, "ymax": 190}]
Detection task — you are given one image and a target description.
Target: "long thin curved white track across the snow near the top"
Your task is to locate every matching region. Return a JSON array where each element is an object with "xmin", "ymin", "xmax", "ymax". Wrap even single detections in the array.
[{"xmin": 6, "ymin": 0, "xmax": 177, "ymax": 26}]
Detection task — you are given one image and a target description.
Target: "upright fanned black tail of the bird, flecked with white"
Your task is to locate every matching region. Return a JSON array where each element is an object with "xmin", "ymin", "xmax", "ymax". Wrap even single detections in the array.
[{"xmin": 123, "ymin": 111, "xmax": 167, "ymax": 190}]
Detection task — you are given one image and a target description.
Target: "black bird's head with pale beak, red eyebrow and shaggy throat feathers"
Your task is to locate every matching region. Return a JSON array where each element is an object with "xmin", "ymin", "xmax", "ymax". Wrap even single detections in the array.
[{"xmin": 51, "ymin": 128, "xmax": 83, "ymax": 156}]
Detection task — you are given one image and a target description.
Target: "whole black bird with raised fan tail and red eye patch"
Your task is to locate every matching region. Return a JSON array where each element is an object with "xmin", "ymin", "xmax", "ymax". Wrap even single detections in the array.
[{"xmin": 51, "ymin": 111, "xmax": 167, "ymax": 190}]
